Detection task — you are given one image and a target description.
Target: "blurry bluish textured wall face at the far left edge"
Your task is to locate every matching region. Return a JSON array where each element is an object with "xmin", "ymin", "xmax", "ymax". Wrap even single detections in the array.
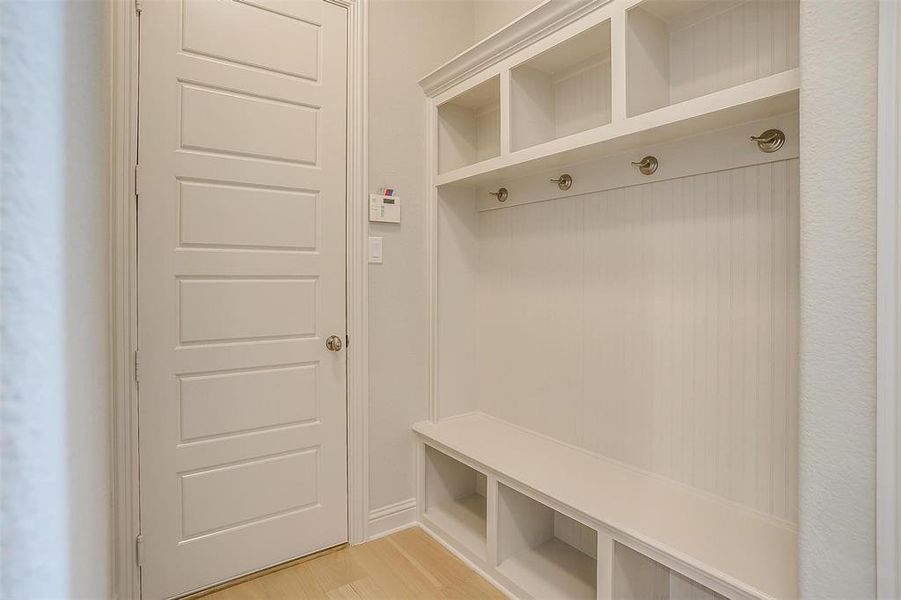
[{"xmin": 0, "ymin": 2, "xmax": 69, "ymax": 598}]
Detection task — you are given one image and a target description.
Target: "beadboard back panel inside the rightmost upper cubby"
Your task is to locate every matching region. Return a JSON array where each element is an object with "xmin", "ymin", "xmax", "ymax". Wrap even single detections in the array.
[{"xmin": 670, "ymin": 0, "xmax": 800, "ymax": 104}]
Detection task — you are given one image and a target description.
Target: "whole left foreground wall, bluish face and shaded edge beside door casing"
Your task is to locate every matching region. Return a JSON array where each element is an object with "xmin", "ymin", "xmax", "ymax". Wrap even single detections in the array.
[{"xmin": 0, "ymin": 2, "xmax": 111, "ymax": 598}]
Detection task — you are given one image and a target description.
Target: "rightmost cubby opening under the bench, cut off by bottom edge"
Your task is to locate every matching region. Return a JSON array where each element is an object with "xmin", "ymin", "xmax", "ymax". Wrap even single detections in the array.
[{"xmin": 613, "ymin": 543, "xmax": 727, "ymax": 600}]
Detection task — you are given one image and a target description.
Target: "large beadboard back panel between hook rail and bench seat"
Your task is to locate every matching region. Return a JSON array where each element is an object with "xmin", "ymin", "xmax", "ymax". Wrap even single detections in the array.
[{"xmin": 474, "ymin": 159, "xmax": 799, "ymax": 522}]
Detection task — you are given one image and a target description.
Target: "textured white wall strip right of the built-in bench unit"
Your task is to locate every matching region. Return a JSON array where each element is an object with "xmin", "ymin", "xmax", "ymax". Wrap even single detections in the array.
[{"xmin": 800, "ymin": 0, "xmax": 878, "ymax": 599}]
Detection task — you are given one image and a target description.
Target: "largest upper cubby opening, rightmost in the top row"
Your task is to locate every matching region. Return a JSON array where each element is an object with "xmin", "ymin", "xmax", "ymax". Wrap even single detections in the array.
[{"xmin": 626, "ymin": 0, "xmax": 799, "ymax": 116}]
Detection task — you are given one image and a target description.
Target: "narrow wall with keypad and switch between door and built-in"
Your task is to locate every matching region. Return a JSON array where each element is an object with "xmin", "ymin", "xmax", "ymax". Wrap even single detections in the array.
[{"xmin": 369, "ymin": 0, "xmax": 473, "ymax": 528}]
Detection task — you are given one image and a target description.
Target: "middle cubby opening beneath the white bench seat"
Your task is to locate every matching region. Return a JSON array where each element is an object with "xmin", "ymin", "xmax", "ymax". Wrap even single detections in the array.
[{"xmin": 497, "ymin": 484, "xmax": 597, "ymax": 600}]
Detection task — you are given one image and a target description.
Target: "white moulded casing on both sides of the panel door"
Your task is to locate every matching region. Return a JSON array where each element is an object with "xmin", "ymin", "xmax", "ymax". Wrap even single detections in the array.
[{"xmin": 108, "ymin": 0, "xmax": 369, "ymax": 599}]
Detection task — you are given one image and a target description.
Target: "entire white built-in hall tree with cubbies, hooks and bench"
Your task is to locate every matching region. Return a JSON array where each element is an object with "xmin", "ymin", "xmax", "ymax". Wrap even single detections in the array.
[{"xmin": 413, "ymin": 0, "xmax": 800, "ymax": 600}]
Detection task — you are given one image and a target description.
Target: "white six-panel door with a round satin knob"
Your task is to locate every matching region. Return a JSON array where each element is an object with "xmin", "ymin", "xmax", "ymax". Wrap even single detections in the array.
[{"xmin": 138, "ymin": 0, "xmax": 347, "ymax": 599}]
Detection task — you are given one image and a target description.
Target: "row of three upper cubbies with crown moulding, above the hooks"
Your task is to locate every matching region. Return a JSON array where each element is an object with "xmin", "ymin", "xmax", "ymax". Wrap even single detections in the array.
[{"xmin": 420, "ymin": 0, "xmax": 800, "ymax": 186}]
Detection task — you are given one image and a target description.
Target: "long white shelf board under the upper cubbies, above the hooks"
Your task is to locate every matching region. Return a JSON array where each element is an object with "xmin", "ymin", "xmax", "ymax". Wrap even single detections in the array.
[{"xmin": 435, "ymin": 69, "xmax": 800, "ymax": 186}]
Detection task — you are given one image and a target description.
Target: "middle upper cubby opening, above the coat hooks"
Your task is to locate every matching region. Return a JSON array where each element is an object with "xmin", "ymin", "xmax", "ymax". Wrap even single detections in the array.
[{"xmin": 510, "ymin": 21, "xmax": 611, "ymax": 150}]
